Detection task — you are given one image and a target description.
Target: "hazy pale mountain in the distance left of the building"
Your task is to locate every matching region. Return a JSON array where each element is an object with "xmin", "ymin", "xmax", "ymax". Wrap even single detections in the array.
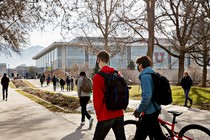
[{"xmin": 0, "ymin": 46, "xmax": 44, "ymax": 68}]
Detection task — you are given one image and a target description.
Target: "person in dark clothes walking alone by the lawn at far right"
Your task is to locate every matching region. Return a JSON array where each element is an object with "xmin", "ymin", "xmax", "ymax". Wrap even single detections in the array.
[{"xmin": 181, "ymin": 71, "xmax": 193, "ymax": 107}]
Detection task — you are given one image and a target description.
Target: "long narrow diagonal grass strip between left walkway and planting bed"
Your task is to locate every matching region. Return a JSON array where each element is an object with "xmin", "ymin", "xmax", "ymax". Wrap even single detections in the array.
[{"xmin": 16, "ymin": 90, "xmax": 69, "ymax": 113}]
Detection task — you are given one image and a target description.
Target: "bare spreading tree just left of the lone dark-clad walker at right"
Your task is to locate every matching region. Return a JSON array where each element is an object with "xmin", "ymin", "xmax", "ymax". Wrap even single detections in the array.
[{"xmin": 156, "ymin": 0, "xmax": 200, "ymax": 83}]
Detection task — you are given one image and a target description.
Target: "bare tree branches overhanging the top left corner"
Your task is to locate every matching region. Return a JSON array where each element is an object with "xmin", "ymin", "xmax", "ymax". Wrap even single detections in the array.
[{"xmin": 0, "ymin": 0, "xmax": 61, "ymax": 54}]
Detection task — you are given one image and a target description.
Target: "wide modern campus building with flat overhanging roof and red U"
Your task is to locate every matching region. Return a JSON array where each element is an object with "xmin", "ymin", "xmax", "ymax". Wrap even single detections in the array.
[{"xmin": 33, "ymin": 37, "xmax": 190, "ymax": 70}]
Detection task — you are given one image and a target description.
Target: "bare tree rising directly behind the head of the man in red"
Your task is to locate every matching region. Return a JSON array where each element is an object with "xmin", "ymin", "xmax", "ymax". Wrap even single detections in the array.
[{"xmin": 61, "ymin": 0, "xmax": 129, "ymax": 55}]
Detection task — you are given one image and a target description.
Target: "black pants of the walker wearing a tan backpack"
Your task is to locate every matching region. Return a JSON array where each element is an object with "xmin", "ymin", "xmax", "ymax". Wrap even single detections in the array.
[{"xmin": 79, "ymin": 96, "xmax": 91, "ymax": 122}]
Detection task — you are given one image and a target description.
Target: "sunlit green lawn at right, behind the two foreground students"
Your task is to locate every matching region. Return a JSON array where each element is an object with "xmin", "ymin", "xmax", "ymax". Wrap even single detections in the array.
[{"xmin": 130, "ymin": 85, "xmax": 210, "ymax": 110}]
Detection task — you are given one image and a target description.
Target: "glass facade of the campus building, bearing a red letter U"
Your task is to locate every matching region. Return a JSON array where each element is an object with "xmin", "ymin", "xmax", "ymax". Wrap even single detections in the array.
[{"xmin": 36, "ymin": 38, "xmax": 190, "ymax": 70}]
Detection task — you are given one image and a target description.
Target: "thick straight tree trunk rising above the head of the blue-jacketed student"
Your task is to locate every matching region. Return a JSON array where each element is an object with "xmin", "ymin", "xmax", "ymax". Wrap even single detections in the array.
[{"xmin": 147, "ymin": 0, "xmax": 155, "ymax": 62}]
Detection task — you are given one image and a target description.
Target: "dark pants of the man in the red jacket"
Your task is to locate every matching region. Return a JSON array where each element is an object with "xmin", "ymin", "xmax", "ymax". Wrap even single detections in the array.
[{"xmin": 93, "ymin": 117, "xmax": 125, "ymax": 140}]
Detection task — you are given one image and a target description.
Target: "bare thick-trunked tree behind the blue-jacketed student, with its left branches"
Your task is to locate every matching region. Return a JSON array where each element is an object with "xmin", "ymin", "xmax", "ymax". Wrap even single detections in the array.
[{"xmin": 120, "ymin": 0, "xmax": 156, "ymax": 60}]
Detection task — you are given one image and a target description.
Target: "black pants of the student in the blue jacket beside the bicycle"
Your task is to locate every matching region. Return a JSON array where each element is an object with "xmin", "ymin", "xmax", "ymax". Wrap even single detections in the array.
[{"xmin": 135, "ymin": 111, "xmax": 166, "ymax": 140}]
